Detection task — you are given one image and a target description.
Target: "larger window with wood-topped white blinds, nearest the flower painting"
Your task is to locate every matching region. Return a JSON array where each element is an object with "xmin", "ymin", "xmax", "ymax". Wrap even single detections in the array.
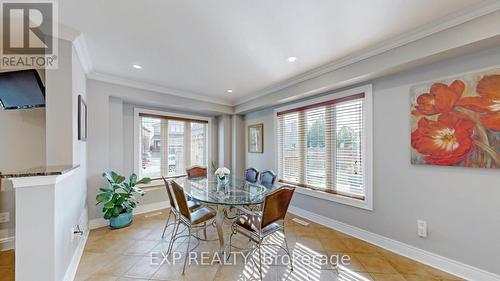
[{"xmin": 277, "ymin": 93, "xmax": 365, "ymax": 200}]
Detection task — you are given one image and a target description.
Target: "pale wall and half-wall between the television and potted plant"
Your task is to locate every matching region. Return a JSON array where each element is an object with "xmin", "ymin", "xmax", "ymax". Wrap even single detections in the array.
[{"xmin": 46, "ymin": 40, "xmax": 88, "ymax": 280}]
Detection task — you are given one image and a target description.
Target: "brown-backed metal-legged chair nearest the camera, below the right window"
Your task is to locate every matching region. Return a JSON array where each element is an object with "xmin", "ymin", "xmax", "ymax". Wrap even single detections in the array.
[{"xmin": 229, "ymin": 186, "xmax": 295, "ymax": 280}]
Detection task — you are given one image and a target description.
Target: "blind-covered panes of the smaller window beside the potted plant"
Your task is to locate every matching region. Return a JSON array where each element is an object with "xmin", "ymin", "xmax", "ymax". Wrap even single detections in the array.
[{"xmin": 139, "ymin": 113, "xmax": 208, "ymax": 179}]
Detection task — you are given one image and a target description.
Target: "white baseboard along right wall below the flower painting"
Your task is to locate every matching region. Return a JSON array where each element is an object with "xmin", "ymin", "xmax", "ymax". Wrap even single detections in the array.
[{"xmin": 288, "ymin": 203, "xmax": 500, "ymax": 281}]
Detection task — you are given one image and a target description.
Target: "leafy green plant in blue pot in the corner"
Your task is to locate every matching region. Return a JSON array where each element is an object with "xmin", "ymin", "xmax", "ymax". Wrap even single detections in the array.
[{"xmin": 96, "ymin": 171, "xmax": 151, "ymax": 228}]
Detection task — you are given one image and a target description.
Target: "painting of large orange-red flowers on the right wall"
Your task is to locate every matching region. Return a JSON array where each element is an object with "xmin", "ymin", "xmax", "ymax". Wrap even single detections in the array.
[{"xmin": 411, "ymin": 69, "xmax": 500, "ymax": 168}]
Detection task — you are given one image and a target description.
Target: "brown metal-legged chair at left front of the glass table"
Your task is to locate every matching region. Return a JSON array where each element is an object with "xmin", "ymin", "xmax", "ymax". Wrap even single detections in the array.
[{"xmin": 167, "ymin": 181, "xmax": 217, "ymax": 274}]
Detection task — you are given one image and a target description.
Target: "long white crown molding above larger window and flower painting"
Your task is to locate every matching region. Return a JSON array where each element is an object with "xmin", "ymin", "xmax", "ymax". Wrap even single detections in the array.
[{"xmin": 234, "ymin": 0, "xmax": 500, "ymax": 106}]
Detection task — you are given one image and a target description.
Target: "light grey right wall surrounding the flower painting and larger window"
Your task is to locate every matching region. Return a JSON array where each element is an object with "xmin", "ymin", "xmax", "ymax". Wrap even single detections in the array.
[{"xmin": 245, "ymin": 48, "xmax": 500, "ymax": 274}]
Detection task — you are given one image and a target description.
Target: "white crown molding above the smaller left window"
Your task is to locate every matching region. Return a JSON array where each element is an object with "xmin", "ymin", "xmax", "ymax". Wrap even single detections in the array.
[{"xmin": 87, "ymin": 71, "xmax": 233, "ymax": 106}]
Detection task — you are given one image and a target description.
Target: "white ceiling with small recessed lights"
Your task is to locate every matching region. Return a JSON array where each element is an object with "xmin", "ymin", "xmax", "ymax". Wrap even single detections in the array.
[{"xmin": 59, "ymin": 0, "xmax": 483, "ymax": 104}]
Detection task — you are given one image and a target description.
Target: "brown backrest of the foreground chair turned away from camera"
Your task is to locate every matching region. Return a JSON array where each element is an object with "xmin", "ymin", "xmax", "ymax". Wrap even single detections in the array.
[{"xmin": 260, "ymin": 186, "xmax": 295, "ymax": 229}]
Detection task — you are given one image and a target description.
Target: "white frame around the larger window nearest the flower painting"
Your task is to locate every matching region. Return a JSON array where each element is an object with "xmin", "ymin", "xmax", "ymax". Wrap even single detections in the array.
[{"xmin": 273, "ymin": 84, "xmax": 373, "ymax": 210}]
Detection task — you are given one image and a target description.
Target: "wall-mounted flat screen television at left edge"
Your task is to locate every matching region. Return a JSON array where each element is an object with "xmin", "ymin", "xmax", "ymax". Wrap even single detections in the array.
[{"xmin": 0, "ymin": 69, "xmax": 45, "ymax": 109}]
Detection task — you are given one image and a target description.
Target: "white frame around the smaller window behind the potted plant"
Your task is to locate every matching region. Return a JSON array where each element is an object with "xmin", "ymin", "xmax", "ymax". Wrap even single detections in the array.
[{"xmin": 134, "ymin": 107, "xmax": 212, "ymax": 182}]
